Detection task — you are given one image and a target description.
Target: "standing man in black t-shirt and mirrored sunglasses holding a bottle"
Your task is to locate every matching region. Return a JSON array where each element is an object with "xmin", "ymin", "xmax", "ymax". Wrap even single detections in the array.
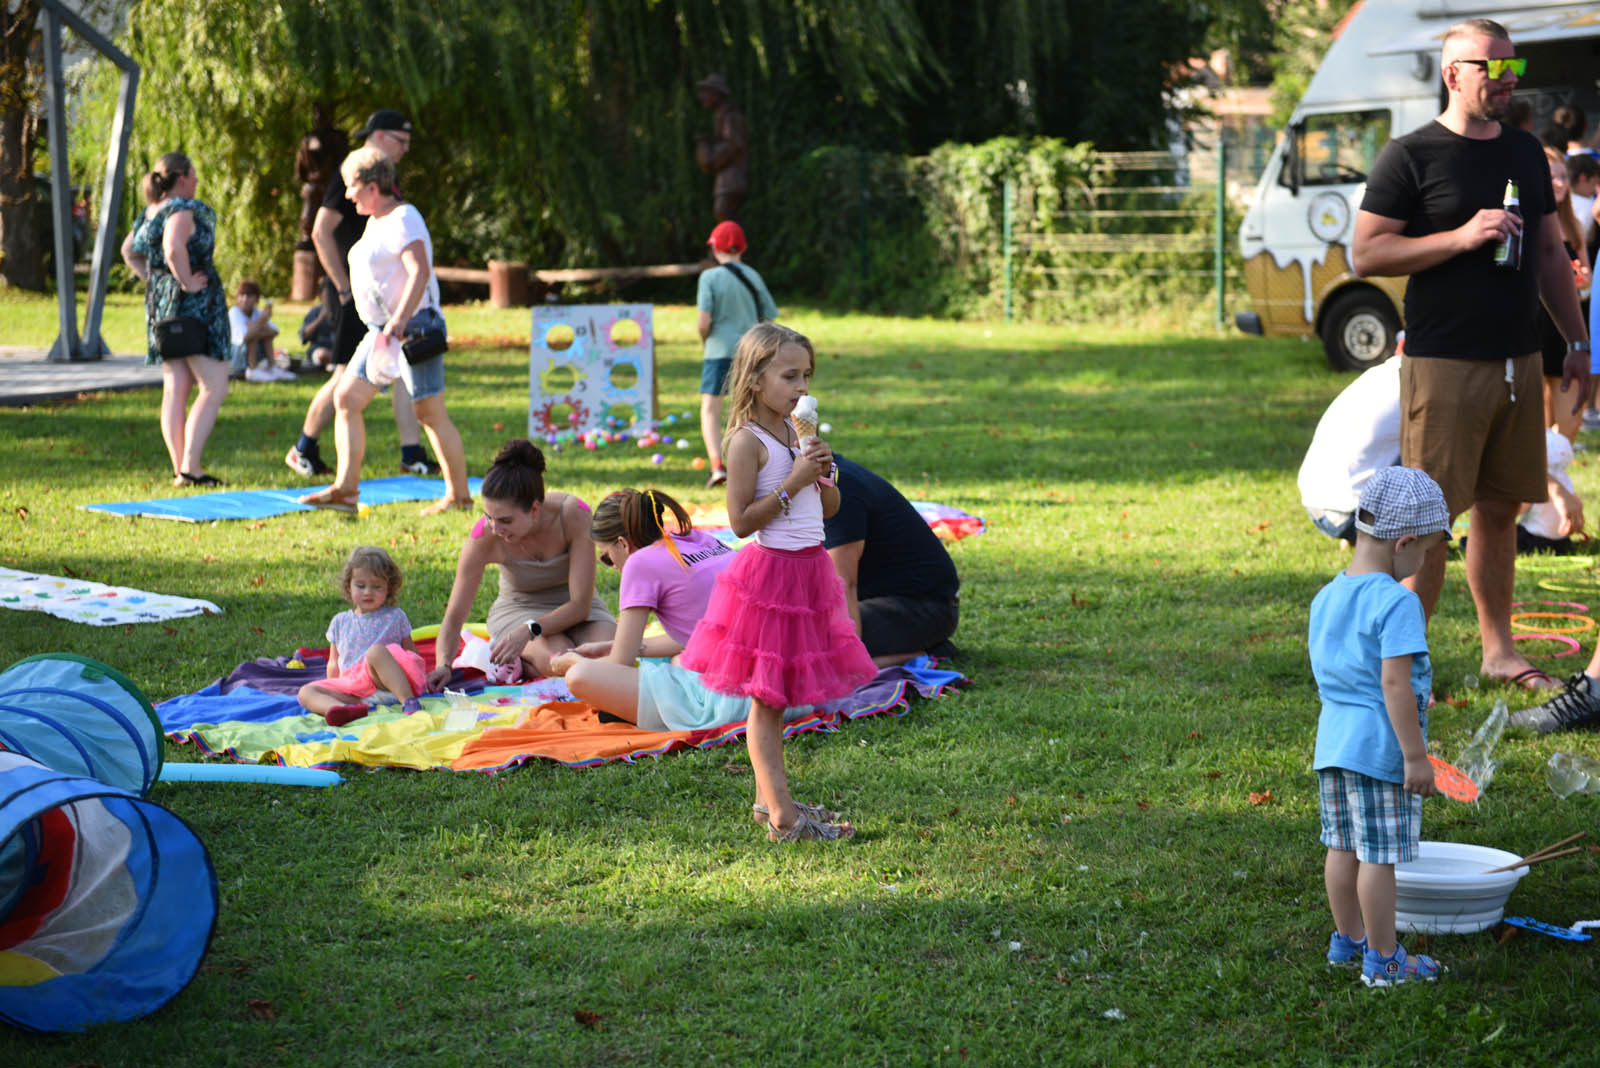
[{"xmin": 1350, "ymin": 19, "xmax": 1589, "ymax": 689}]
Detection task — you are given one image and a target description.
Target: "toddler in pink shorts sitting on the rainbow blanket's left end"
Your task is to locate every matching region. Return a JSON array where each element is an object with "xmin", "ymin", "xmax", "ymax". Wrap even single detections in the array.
[{"xmin": 299, "ymin": 545, "xmax": 426, "ymax": 727}]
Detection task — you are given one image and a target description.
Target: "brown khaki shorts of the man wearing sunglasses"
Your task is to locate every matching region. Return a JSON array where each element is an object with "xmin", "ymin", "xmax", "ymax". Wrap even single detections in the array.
[{"xmin": 1400, "ymin": 352, "xmax": 1547, "ymax": 518}]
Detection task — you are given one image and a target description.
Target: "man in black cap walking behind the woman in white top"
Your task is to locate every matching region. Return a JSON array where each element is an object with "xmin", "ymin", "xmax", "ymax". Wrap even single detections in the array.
[{"xmin": 283, "ymin": 107, "xmax": 438, "ymax": 478}]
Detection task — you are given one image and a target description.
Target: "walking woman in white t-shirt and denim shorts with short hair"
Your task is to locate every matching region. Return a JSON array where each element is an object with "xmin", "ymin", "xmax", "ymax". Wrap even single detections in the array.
[{"xmin": 301, "ymin": 147, "xmax": 472, "ymax": 515}]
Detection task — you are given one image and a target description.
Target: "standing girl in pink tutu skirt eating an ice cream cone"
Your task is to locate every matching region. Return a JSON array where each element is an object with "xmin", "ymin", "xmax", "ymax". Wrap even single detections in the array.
[{"xmin": 680, "ymin": 323, "xmax": 877, "ymax": 841}]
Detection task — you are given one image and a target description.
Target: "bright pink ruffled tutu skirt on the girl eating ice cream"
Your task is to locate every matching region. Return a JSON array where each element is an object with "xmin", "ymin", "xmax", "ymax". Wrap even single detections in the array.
[{"xmin": 678, "ymin": 542, "xmax": 878, "ymax": 708}]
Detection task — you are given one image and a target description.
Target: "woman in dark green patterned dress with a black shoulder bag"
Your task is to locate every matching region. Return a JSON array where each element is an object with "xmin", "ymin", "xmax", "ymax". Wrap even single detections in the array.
[{"xmin": 122, "ymin": 152, "xmax": 230, "ymax": 486}]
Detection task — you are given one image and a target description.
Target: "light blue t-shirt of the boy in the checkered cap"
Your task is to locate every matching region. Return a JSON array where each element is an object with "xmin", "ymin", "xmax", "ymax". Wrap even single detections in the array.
[{"xmin": 1306, "ymin": 571, "xmax": 1434, "ymax": 783}]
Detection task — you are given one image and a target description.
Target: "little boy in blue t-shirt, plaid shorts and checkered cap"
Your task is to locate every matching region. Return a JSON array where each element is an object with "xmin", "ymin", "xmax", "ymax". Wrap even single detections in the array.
[{"xmin": 1307, "ymin": 467, "xmax": 1450, "ymax": 986}]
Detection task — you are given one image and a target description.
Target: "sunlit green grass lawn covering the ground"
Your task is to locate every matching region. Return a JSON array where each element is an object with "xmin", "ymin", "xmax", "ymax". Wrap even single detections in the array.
[{"xmin": 0, "ymin": 287, "xmax": 1600, "ymax": 1068}]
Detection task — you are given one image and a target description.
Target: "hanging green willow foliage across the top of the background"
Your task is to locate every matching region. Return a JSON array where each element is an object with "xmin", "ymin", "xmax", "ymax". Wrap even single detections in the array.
[{"xmin": 90, "ymin": 0, "xmax": 1258, "ymax": 294}]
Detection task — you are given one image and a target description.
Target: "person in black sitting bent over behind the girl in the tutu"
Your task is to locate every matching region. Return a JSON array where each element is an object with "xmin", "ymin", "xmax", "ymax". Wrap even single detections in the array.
[{"xmin": 822, "ymin": 452, "xmax": 962, "ymax": 667}]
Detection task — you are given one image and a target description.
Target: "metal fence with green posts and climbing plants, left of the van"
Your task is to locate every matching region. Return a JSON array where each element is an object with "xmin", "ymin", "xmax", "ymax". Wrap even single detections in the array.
[{"xmin": 1002, "ymin": 145, "xmax": 1227, "ymax": 329}]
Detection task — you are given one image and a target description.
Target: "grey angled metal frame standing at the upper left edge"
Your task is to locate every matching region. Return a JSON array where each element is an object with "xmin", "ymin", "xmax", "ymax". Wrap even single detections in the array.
[{"xmin": 42, "ymin": 0, "xmax": 139, "ymax": 361}]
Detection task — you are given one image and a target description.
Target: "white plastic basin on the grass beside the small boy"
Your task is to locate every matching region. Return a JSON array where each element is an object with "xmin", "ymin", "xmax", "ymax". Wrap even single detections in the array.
[{"xmin": 1395, "ymin": 843, "xmax": 1528, "ymax": 934}]
